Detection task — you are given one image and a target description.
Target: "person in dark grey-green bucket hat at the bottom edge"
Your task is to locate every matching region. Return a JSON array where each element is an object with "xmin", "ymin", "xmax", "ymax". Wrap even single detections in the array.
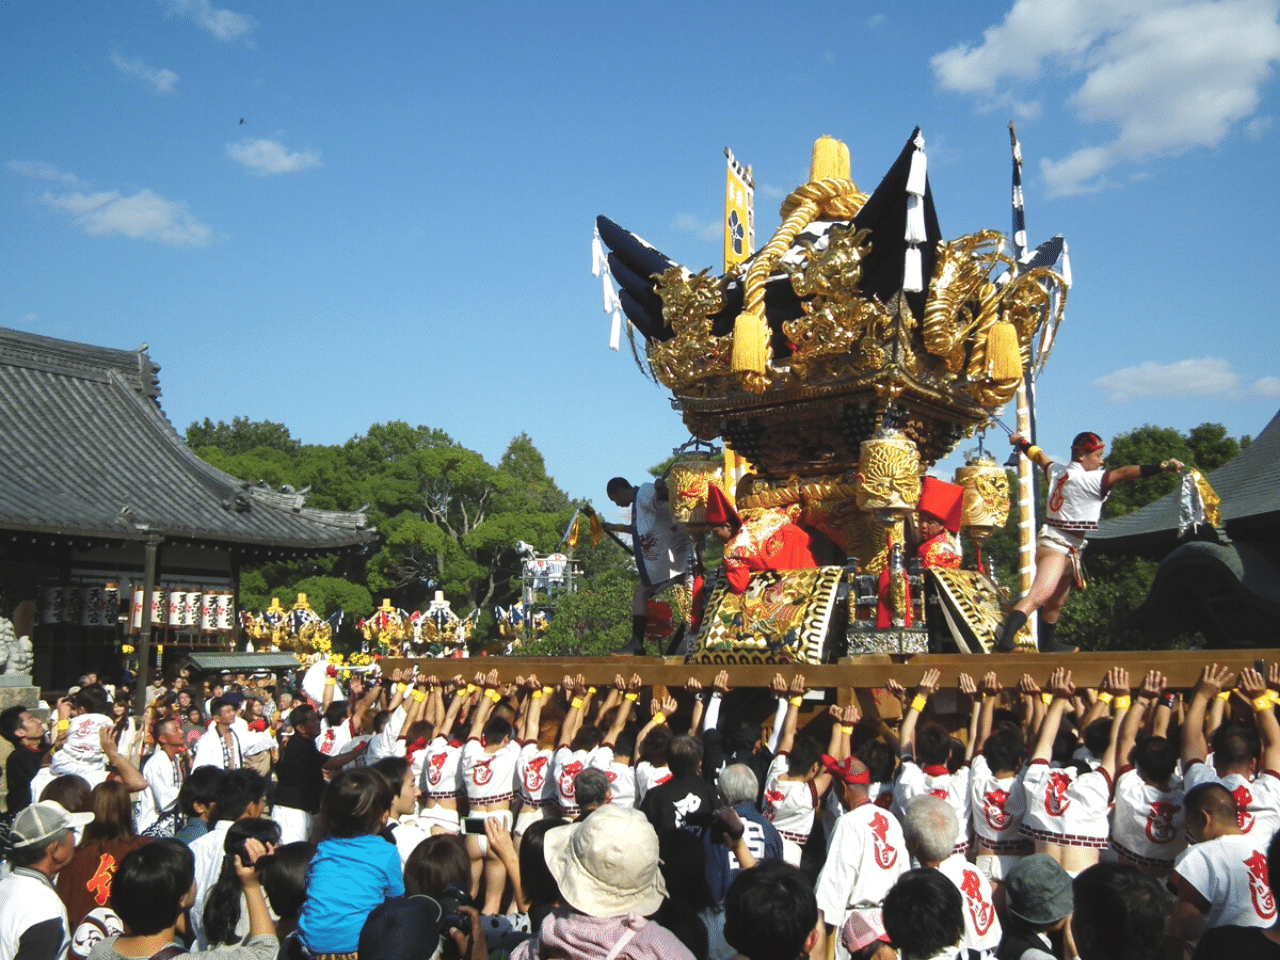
[{"xmin": 993, "ymin": 854, "xmax": 1079, "ymax": 960}]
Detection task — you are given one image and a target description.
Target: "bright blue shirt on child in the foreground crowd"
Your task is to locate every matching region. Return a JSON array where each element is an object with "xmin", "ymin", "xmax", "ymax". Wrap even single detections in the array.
[{"xmin": 298, "ymin": 835, "xmax": 404, "ymax": 954}]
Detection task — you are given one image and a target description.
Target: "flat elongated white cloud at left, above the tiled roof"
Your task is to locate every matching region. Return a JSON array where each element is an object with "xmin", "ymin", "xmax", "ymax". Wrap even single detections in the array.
[{"xmin": 40, "ymin": 189, "xmax": 210, "ymax": 247}]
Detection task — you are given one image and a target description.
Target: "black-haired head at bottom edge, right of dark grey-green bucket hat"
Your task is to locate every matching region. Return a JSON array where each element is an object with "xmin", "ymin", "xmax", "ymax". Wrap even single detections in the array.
[{"xmin": 1071, "ymin": 863, "xmax": 1169, "ymax": 960}]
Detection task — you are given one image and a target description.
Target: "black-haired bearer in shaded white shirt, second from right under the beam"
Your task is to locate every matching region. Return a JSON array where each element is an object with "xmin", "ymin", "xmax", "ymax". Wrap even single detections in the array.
[{"xmin": 1111, "ymin": 671, "xmax": 1182, "ymax": 879}]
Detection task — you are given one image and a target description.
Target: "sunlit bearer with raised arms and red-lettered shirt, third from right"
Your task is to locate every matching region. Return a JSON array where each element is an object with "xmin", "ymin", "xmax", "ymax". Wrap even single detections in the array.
[{"xmin": 1023, "ymin": 667, "xmax": 1129, "ymax": 877}]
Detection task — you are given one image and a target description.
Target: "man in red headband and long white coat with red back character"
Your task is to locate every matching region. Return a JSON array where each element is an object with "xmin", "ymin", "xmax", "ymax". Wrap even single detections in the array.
[{"xmin": 814, "ymin": 756, "xmax": 906, "ymax": 960}]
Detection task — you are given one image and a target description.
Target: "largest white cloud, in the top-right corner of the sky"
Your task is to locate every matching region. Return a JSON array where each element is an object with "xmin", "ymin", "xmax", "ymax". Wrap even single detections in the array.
[{"xmin": 932, "ymin": 0, "xmax": 1280, "ymax": 196}]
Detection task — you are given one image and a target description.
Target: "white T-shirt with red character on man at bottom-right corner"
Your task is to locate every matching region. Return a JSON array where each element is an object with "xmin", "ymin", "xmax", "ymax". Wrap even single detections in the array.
[{"xmin": 1169, "ymin": 833, "xmax": 1276, "ymax": 931}]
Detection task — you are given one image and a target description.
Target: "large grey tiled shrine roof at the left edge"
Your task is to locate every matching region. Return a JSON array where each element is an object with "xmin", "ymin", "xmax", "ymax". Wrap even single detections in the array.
[{"xmin": 0, "ymin": 329, "xmax": 376, "ymax": 550}]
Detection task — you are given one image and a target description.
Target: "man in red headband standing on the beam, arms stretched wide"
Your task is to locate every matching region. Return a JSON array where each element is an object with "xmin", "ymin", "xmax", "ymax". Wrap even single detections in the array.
[{"xmin": 996, "ymin": 431, "xmax": 1183, "ymax": 653}]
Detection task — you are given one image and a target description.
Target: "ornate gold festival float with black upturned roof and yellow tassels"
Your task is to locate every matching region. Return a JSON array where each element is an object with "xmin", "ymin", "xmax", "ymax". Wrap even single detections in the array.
[{"xmin": 595, "ymin": 129, "xmax": 1069, "ymax": 664}]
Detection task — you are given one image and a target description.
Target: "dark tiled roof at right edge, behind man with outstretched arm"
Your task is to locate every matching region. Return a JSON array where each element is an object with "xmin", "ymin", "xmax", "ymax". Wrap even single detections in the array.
[{"xmin": 1089, "ymin": 413, "xmax": 1280, "ymax": 549}]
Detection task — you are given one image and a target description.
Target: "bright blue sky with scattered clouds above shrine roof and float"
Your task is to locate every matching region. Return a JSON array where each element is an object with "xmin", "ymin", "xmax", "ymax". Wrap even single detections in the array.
[{"xmin": 0, "ymin": 0, "xmax": 1280, "ymax": 514}]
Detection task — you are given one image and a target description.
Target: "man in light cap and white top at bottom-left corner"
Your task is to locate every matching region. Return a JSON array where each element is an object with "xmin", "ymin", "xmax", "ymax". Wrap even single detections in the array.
[{"xmin": 0, "ymin": 800, "xmax": 93, "ymax": 960}]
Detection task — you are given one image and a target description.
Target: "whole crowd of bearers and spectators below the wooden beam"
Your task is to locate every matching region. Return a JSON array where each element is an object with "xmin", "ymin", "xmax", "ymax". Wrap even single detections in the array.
[{"xmin": 0, "ymin": 664, "xmax": 1280, "ymax": 960}]
